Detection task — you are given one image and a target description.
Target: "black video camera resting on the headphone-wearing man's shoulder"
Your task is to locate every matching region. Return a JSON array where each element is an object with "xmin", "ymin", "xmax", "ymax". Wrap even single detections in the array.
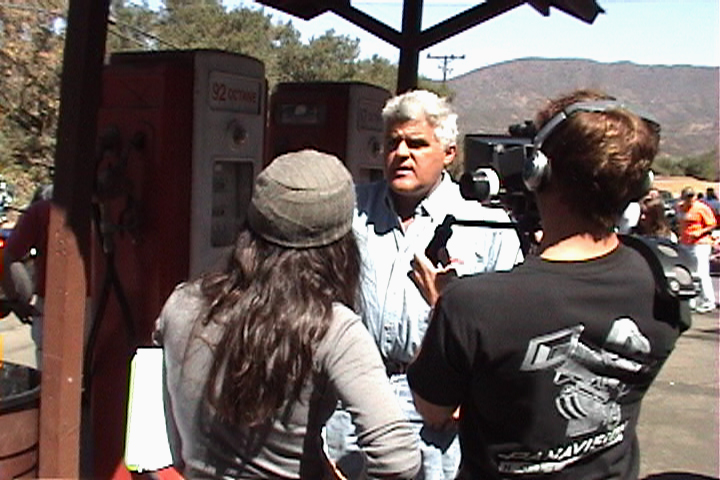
[{"xmin": 434, "ymin": 117, "xmax": 699, "ymax": 332}]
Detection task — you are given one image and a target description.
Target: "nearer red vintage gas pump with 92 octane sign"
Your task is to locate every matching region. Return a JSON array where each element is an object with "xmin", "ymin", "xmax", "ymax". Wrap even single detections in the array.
[{"xmin": 84, "ymin": 50, "xmax": 267, "ymax": 478}]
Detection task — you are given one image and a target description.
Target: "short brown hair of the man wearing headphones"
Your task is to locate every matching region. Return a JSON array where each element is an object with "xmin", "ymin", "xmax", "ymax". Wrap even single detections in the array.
[{"xmin": 535, "ymin": 90, "xmax": 660, "ymax": 233}]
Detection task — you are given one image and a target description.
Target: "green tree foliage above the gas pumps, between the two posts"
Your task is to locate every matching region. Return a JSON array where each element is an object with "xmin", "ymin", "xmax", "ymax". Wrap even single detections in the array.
[{"xmin": 108, "ymin": 0, "xmax": 397, "ymax": 90}]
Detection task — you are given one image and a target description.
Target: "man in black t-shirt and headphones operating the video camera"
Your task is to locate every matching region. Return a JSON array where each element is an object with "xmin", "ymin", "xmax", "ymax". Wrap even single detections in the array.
[{"xmin": 408, "ymin": 90, "xmax": 680, "ymax": 480}]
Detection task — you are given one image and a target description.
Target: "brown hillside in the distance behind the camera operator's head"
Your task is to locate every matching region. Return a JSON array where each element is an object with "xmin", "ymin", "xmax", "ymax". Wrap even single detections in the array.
[{"xmin": 447, "ymin": 58, "xmax": 720, "ymax": 156}]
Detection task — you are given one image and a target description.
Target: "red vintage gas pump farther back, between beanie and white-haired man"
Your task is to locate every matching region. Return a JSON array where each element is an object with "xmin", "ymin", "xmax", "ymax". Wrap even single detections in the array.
[{"xmin": 266, "ymin": 82, "xmax": 391, "ymax": 183}]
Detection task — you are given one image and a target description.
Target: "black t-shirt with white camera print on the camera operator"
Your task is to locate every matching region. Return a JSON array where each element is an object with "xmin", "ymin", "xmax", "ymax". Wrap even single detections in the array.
[{"xmin": 408, "ymin": 246, "xmax": 679, "ymax": 480}]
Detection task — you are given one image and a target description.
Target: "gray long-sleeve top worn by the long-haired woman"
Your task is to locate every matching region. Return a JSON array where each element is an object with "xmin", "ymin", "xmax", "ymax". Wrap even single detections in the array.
[{"xmin": 155, "ymin": 283, "xmax": 420, "ymax": 479}]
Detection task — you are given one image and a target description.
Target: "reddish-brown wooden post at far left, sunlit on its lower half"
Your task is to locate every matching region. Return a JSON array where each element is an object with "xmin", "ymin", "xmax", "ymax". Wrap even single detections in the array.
[{"xmin": 39, "ymin": 0, "xmax": 109, "ymax": 478}]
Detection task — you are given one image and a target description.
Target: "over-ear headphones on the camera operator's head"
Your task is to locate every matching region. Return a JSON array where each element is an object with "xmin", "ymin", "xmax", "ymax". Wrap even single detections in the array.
[{"xmin": 523, "ymin": 100, "xmax": 660, "ymax": 192}]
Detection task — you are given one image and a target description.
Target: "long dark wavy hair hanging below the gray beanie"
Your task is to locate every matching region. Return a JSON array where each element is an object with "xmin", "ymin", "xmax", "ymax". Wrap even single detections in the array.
[{"xmin": 199, "ymin": 230, "xmax": 361, "ymax": 426}]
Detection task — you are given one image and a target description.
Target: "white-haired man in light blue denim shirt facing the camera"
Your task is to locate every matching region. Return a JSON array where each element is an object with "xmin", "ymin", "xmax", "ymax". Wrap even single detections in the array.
[{"xmin": 327, "ymin": 90, "xmax": 522, "ymax": 480}]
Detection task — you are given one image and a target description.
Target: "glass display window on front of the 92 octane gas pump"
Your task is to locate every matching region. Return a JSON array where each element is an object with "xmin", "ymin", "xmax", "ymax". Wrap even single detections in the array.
[{"xmin": 210, "ymin": 160, "xmax": 254, "ymax": 248}]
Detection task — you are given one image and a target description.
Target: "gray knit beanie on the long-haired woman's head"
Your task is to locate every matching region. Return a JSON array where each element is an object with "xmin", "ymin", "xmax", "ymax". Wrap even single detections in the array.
[{"xmin": 247, "ymin": 150, "xmax": 355, "ymax": 248}]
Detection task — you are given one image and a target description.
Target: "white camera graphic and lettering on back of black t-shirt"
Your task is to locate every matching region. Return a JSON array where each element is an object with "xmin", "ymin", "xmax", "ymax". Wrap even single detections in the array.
[{"xmin": 498, "ymin": 318, "xmax": 650, "ymax": 473}]
